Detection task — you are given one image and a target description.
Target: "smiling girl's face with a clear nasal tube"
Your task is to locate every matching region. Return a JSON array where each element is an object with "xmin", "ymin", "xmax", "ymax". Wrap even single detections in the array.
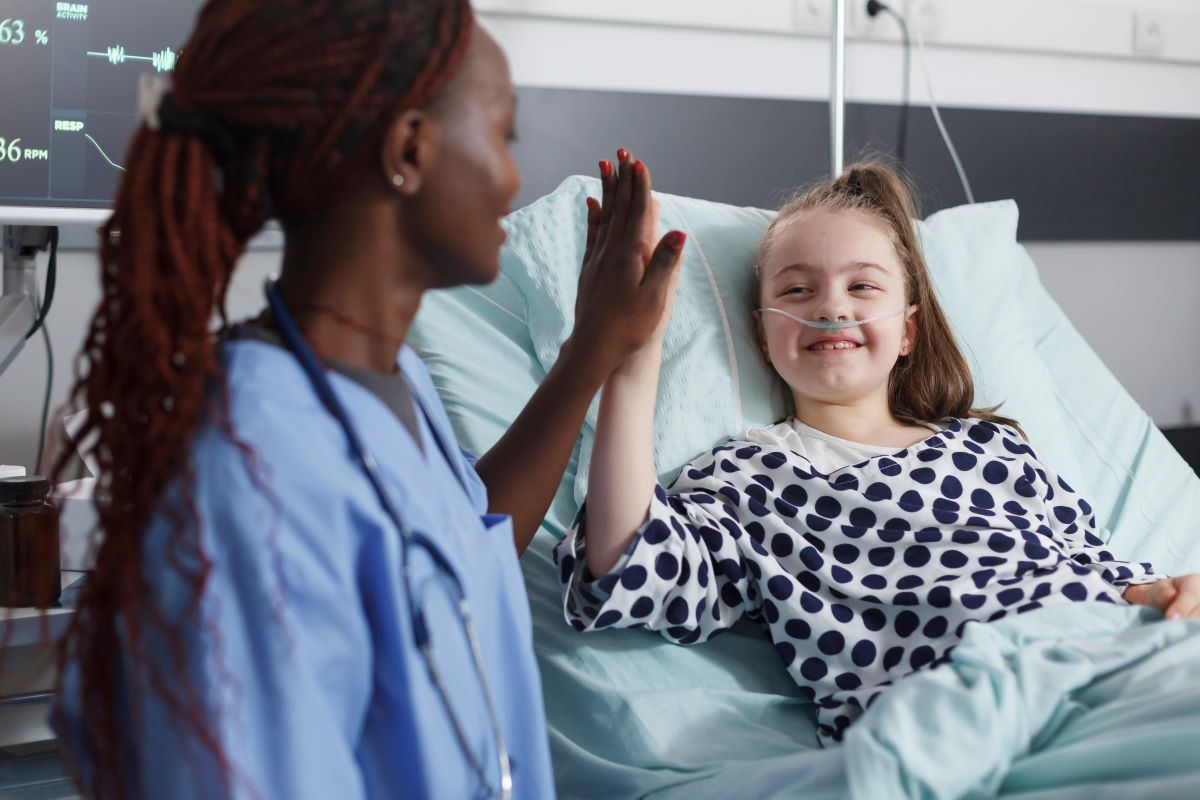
[{"xmin": 755, "ymin": 210, "xmax": 917, "ymax": 411}]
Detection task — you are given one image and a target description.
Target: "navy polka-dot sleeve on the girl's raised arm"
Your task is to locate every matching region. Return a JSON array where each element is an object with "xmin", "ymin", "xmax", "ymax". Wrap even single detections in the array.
[{"xmin": 554, "ymin": 447, "xmax": 762, "ymax": 644}]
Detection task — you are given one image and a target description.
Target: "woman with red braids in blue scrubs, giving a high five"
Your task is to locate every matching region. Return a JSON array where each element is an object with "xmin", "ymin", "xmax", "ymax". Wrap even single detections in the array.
[{"xmin": 55, "ymin": 0, "xmax": 683, "ymax": 800}]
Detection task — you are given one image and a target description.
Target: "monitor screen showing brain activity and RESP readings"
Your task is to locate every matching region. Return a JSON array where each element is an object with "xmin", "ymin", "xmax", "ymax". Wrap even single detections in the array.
[{"xmin": 0, "ymin": 0, "xmax": 203, "ymax": 224}]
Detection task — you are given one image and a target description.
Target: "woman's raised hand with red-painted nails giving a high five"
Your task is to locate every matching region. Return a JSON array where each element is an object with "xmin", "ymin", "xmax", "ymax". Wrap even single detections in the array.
[{"xmin": 568, "ymin": 149, "xmax": 685, "ymax": 377}]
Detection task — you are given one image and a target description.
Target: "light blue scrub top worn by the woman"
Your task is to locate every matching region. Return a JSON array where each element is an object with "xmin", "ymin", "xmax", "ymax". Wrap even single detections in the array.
[{"xmin": 56, "ymin": 341, "xmax": 553, "ymax": 800}]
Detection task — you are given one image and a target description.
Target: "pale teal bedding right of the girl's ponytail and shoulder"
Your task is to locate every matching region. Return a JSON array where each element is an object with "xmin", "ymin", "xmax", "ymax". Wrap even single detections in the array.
[{"xmin": 918, "ymin": 200, "xmax": 1200, "ymax": 575}]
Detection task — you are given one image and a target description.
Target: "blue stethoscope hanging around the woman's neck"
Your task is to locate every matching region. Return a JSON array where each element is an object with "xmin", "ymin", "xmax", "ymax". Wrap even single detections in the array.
[{"xmin": 264, "ymin": 279, "xmax": 512, "ymax": 800}]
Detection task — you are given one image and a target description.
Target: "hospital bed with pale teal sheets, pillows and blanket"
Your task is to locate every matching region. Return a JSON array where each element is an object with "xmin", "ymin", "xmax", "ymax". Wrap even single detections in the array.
[{"xmin": 410, "ymin": 178, "xmax": 1200, "ymax": 799}]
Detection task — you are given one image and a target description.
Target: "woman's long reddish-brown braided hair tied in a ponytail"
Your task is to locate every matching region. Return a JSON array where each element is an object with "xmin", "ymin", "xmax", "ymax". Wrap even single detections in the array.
[{"xmin": 54, "ymin": 0, "xmax": 473, "ymax": 798}]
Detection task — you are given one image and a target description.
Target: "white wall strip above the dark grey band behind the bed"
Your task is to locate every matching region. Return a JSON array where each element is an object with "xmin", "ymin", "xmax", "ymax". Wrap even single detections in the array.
[{"xmin": 484, "ymin": 0, "xmax": 1200, "ymax": 115}]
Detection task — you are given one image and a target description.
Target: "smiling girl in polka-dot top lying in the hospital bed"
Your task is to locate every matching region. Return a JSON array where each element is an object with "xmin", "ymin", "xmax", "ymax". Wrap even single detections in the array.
[{"xmin": 556, "ymin": 163, "xmax": 1200, "ymax": 740}]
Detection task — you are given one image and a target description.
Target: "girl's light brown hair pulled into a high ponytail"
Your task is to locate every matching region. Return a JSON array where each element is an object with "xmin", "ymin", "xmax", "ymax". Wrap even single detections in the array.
[{"xmin": 755, "ymin": 161, "xmax": 1024, "ymax": 435}]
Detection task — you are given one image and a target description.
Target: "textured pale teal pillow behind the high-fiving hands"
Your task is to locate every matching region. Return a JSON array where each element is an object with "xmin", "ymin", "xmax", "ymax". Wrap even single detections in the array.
[{"xmin": 502, "ymin": 176, "xmax": 786, "ymax": 503}]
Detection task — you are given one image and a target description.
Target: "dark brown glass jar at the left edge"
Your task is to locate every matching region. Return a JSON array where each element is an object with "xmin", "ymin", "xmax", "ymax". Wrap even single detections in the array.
[{"xmin": 0, "ymin": 475, "xmax": 61, "ymax": 608}]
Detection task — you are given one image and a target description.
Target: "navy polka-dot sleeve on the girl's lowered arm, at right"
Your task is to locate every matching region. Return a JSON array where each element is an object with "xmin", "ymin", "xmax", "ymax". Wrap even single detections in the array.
[{"xmin": 1014, "ymin": 432, "xmax": 1163, "ymax": 587}]
